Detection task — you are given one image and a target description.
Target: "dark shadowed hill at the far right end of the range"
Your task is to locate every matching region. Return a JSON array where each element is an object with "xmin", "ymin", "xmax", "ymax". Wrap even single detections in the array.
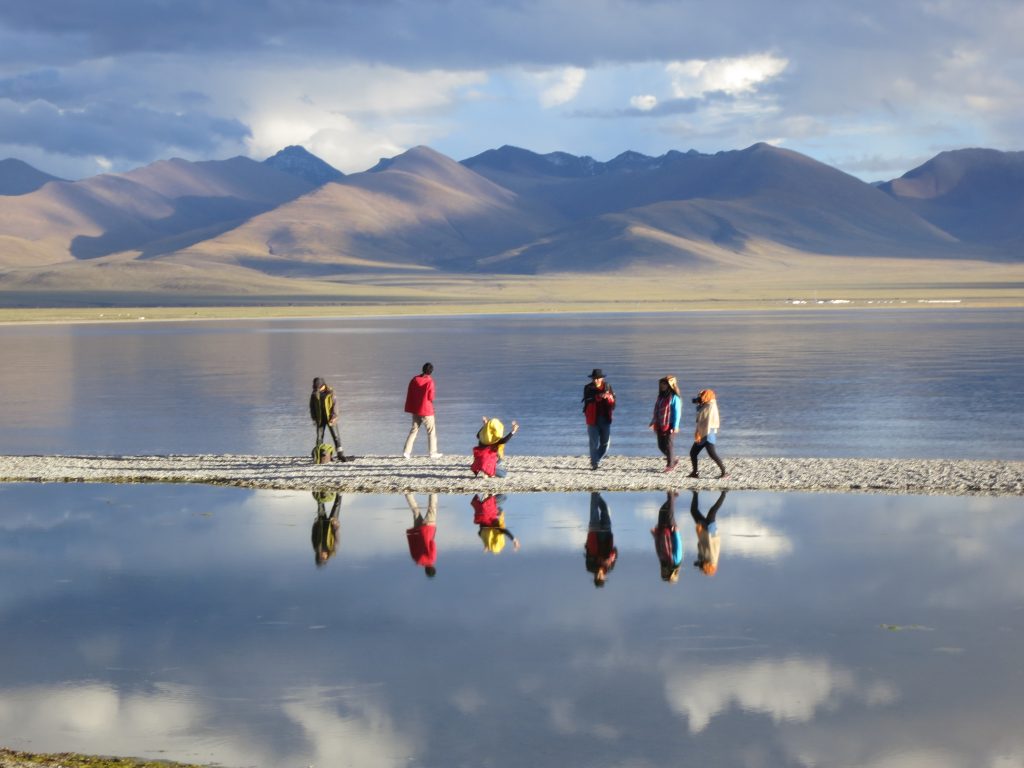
[{"xmin": 879, "ymin": 150, "xmax": 1024, "ymax": 249}]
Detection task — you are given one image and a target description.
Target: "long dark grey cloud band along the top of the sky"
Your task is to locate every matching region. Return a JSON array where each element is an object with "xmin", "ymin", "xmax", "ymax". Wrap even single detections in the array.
[{"xmin": 0, "ymin": 0, "xmax": 959, "ymax": 69}]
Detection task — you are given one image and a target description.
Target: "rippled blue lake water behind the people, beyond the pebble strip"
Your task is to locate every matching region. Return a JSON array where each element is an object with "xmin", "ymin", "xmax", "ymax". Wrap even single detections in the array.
[{"xmin": 0, "ymin": 308, "xmax": 1024, "ymax": 459}]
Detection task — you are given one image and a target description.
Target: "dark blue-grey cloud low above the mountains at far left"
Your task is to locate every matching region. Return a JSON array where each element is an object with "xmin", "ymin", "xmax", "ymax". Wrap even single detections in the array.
[{"xmin": 0, "ymin": 100, "xmax": 249, "ymax": 162}]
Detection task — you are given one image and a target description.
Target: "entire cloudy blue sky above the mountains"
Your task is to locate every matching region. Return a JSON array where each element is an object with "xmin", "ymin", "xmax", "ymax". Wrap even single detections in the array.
[{"xmin": 0, "ymin": 0, "xmax": 1024, "ymax": 181}]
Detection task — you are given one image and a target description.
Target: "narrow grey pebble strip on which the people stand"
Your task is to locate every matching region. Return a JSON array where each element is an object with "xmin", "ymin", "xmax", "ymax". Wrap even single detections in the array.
[{"xmin": 0, "ymin": 455, "xmax": 1024, "ymax": 496}]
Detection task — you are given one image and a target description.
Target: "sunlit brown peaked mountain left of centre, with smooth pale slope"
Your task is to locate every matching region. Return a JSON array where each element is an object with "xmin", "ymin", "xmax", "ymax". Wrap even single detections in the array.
[{"xmin": 174, "ymin": 147, "xmax": 562, "ymax": 274}]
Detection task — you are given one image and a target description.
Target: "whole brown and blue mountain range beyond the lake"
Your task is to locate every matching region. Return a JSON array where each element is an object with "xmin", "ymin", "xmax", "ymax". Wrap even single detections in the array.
[{"xmin": 0, "ymin": 143, "xmax": 1024, "ymax": 295}]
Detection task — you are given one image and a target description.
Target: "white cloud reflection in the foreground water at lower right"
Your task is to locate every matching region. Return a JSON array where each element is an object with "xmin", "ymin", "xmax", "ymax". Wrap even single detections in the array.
[{"xmin": 666, "ymin": 658, "xmax": 897, "ymax": 733}]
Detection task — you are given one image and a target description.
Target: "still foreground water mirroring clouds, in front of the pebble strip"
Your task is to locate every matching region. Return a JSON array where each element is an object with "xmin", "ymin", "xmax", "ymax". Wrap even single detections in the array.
[{"xmin": 0, "ymin": 487, "xmax": 1024, "ymax": 768}]
